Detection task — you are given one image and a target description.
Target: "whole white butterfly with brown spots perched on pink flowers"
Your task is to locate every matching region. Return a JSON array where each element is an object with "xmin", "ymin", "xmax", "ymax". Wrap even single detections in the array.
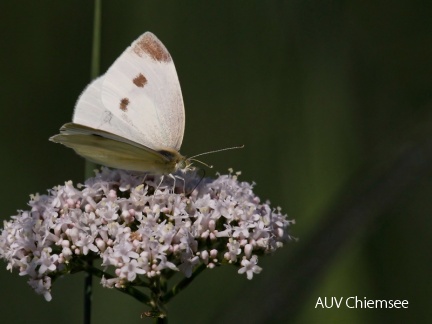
[{"xmin": 50, "ymin": 32, "xmax": 191, "ymax": 174}]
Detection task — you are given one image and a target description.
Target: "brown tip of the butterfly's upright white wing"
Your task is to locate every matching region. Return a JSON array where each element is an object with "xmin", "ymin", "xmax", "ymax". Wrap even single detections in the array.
[{"xmin": 132, "ymin": 32, "xmax": 172, "ymax": 62}]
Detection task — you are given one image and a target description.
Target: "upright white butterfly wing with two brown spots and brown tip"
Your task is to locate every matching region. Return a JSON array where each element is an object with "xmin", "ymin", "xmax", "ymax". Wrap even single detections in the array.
[{"xmin": 73, "ymin": 32, "xmax": 185, "ymax": 151}]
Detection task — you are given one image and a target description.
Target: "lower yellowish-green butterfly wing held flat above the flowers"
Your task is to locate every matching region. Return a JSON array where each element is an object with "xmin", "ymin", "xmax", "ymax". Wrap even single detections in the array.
[{"xmin": 50, "ymin": 123, "xmax": 184, "ymax": 174}]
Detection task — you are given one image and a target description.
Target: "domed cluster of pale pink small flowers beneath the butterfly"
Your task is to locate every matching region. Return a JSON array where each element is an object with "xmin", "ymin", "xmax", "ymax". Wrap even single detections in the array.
[{"xmin": 0, "ymin": 168, "xmax": 292, "ymax": 300}]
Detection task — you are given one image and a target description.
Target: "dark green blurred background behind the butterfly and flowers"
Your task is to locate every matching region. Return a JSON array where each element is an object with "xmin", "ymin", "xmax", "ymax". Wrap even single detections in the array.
[{"xmin": 0, "ymin": 0, "xmax": 432, "ymax": 324}]
